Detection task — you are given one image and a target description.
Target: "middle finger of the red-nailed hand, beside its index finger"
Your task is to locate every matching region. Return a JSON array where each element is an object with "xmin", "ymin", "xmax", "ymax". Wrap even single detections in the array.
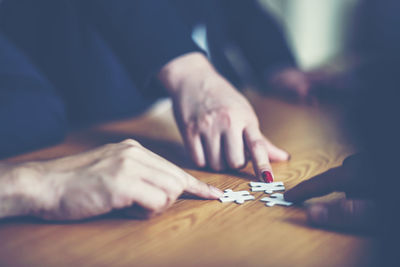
[{"xmin": 223, "ymin": 130, "xmax": 246, "ymax": 169}]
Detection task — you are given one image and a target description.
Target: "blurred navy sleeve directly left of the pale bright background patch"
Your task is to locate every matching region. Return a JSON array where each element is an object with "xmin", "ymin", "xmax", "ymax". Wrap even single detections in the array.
[{"xmin": 221, "ymin": 0, "xmax": 296, "ymax": 78}]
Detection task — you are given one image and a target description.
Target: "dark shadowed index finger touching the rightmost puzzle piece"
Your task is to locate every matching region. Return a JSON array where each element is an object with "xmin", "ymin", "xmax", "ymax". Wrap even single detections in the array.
[{"xmin": 285, "ymin": 167, "xmax": 346, "ymax": 202}]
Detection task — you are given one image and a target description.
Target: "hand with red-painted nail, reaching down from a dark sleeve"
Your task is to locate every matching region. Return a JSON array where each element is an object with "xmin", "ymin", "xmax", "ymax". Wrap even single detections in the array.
[{"xmin": 159, "ymin": 53, "xmax": 289, "ymax": 182}]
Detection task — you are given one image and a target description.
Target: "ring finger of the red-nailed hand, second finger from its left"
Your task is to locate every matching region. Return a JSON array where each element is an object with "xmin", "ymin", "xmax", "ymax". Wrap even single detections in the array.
[{"xmin": 202, "ymin": 133, "xmax": 225, "ymax": 171}]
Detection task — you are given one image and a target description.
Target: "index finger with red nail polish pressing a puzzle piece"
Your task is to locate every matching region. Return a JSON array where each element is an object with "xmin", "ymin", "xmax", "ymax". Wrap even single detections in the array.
[{"xmin": 244, "ymin": 128, "xmax": 273, "ymax": 182}]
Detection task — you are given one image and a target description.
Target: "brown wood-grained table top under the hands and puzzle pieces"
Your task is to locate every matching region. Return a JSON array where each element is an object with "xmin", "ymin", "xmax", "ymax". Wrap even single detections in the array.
[{"xmin": 0, "ymin": 92, "xmax": 374, "ymax": 266}]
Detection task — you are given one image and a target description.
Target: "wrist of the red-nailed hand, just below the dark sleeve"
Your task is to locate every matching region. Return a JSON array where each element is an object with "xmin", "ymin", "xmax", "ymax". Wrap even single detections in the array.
[{"xmin": 158, "ymin": 52, "xmax": 215, "ymax": 95}]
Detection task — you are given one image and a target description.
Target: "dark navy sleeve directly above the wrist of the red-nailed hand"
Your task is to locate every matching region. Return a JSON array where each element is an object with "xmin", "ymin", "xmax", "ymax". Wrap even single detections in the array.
[{"xmin": 82, "ymin": 0, "xmax": 205, "ymax": 88}]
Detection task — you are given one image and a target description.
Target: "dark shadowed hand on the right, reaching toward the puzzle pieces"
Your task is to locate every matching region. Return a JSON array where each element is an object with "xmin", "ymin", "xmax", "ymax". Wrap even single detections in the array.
[{"xmin": 285, "ymin": 155, "xmax": 377, "ymax": 230}]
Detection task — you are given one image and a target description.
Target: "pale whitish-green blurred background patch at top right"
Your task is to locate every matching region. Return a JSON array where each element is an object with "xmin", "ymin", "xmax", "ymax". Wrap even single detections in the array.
[{"xmin": 259, "ymin": 0, "xmax": 362, "ymax": 70}]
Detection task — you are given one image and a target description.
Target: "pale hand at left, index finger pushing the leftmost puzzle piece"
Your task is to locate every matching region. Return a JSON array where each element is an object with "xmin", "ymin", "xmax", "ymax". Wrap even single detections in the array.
[{"xmin": 0, "ymin": 140, "xmax": 222, "ymax": 220}]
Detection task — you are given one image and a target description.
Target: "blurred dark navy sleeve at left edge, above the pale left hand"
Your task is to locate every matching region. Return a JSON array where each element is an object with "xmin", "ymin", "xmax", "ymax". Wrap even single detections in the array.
[{"xmin": 0, "ymin": 33, "xmax": 67, "ymax": 158}]
